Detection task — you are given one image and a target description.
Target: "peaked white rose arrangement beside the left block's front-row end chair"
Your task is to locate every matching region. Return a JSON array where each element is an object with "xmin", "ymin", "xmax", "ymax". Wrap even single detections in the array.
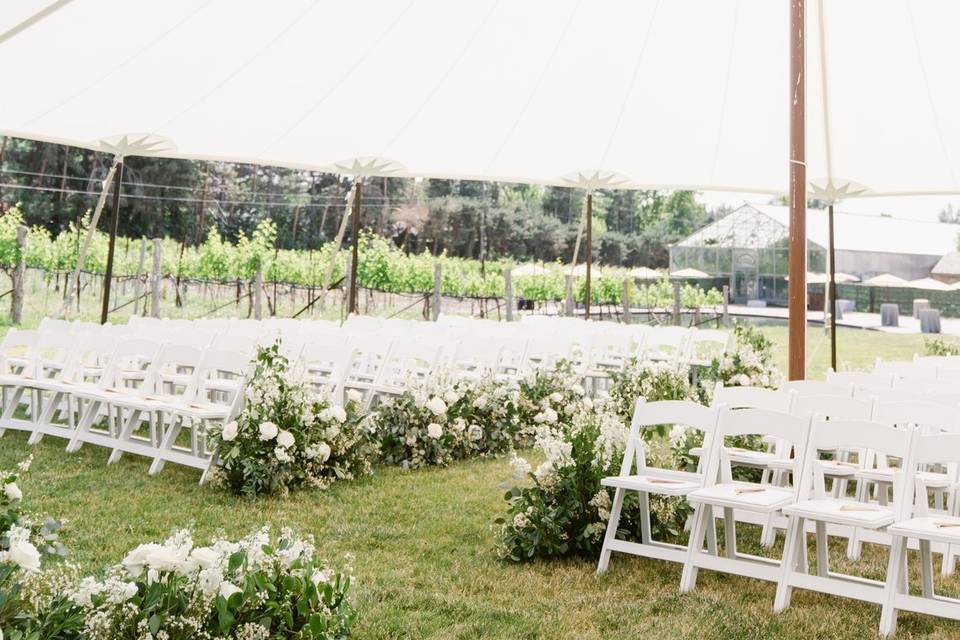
[{"xmin": 211, "ymin": 343, "xmax": 378, "ymax": 496}]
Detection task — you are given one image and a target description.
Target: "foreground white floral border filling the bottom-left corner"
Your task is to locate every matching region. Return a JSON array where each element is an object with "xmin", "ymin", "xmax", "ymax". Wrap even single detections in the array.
[{"xmin": 0, "ymin": 452, "xmax": 357, "ymax": 640}]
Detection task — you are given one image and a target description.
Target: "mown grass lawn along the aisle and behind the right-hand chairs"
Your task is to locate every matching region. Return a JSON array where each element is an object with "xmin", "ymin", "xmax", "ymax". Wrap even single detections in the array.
[{"xmin": 0, "ymin": 327, "xmax": 960, "ymax": 640}]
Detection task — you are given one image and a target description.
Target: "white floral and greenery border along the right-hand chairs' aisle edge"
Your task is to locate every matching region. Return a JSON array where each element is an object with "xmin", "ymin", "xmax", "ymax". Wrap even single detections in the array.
[{"xmin": 496, "ymin": 324, "xmax": 780, "ymax": 562}]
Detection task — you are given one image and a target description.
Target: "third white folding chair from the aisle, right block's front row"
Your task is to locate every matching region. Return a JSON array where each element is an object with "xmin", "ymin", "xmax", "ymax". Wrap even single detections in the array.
[{"xmin": 774, "ymin": 419, "xmax": 914, "ymax": 612}]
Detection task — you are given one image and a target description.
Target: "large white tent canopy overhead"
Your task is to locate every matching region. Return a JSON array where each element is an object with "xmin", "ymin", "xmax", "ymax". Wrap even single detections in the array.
[{"xmin": 0, "ymin": 0, "xmax": 960, "ymax": 195}]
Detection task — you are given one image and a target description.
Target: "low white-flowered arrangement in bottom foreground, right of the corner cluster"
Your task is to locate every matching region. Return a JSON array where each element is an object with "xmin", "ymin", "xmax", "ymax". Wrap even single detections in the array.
[{"xmin": 70, "ymin": 529, "xmax": 356, "ymax": 640}]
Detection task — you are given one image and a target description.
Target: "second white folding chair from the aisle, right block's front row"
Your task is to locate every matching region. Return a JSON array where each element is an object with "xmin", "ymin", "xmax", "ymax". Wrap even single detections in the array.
[{"xmin": 680, "ymin": 408, "xmax": 811, "ymax": 593}]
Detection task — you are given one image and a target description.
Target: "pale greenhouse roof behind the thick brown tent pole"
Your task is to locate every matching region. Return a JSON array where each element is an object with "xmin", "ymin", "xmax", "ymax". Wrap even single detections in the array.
[{"xmin": 677, "ymin": 204, "xmax": 960, "ymax": 256}]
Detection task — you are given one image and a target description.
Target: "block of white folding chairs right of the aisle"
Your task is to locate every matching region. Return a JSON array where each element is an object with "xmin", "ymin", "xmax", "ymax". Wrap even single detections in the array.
[{"xmin": 598, "ymin": 376, "xmax": 960, "ymax": 635}]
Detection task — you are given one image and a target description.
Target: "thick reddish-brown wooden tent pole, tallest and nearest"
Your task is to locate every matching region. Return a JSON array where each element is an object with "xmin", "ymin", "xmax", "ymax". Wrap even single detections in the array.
[{"xmin": 787, "ymin": 0, "xmax": 807, "ymax": 380}]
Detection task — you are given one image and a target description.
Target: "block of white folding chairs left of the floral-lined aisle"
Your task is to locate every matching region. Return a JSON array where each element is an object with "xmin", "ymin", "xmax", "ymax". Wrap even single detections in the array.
[{"xmin": 0, "ymin": 318, "xmax": 727, "ymax": 482}]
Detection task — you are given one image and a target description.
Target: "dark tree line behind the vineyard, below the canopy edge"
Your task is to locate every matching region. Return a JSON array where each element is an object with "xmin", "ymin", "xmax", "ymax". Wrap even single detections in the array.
[{"xmin": 0, "ymin": 137, "xmax": 722, "ymax": 267}]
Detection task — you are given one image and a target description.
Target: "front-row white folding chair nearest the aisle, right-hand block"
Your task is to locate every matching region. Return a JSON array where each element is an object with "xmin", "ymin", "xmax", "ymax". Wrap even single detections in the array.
[{"xmin": 597, "ymin": 398, "xmax": 718, "ymax": 573}]
